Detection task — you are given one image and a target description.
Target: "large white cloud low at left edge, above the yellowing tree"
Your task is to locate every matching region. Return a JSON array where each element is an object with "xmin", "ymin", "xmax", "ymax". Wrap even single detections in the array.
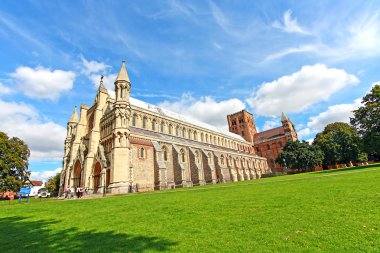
[{"xmin": 0, "ymin": 100, "xmax": 66, "ymax": 160}]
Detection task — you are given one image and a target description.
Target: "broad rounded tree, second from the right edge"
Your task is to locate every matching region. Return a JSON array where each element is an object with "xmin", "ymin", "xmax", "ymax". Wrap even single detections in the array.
[{"xmin": 313, "ymin": 122, "xmax": 363, "ymax": 167}]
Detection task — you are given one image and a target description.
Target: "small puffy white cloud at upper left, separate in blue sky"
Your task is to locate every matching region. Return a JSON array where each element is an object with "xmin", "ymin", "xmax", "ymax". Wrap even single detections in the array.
[{"xmin": 10, "ymin": 67, "xmax": 75, "ymax": 100}]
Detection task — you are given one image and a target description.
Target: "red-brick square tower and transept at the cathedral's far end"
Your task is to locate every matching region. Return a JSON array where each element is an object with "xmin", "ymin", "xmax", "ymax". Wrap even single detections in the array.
[{"xmin": 227, "ymin": 110, "xmax": 298, "ymax": 172}]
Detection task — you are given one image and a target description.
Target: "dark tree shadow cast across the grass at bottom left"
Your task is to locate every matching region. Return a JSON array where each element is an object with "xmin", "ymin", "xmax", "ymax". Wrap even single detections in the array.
[{"xmin": 0, "ymin": 216, "xmax": 177, "ymax": 252}]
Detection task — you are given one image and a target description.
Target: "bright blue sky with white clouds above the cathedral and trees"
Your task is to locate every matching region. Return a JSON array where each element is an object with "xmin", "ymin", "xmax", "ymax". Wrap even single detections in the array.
[{"xmin": 0, "ymin": 0, "xmax": 380, "ymax": 179}]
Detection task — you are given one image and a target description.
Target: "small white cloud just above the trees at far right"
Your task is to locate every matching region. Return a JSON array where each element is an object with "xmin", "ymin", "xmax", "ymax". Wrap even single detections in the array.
[{"xmin": 307, "ymin": 99, "xmax": 361, "ymax": 132}]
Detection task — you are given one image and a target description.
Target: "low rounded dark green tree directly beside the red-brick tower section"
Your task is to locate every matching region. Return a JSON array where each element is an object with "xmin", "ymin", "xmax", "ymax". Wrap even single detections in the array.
[{"xmin": 276, "ymin": 141, "xmax": 323, "ymax": 171}]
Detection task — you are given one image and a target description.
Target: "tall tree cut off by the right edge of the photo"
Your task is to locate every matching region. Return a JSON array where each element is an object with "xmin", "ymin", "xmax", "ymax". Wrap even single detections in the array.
[{"xmin": 350, "ymin": 85, "xmax": 380, "ymax": 160}]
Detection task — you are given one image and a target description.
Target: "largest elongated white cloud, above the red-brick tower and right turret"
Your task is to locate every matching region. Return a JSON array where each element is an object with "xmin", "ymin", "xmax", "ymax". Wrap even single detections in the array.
[{"xmin": 246, "ymin": 64, "xmax": 359, "ymax": 116}]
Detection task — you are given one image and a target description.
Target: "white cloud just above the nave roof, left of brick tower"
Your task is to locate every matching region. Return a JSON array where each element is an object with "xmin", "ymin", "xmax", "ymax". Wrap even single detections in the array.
[{"xmin": 159, "ymin": 93, "xmax": 245, "ymax": 129}]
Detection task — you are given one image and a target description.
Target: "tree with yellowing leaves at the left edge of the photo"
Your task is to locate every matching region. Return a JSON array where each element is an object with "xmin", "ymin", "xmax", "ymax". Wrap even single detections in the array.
[{"xmin": 0, "ymin": 132, "xmax": 30, "ymax": 191}]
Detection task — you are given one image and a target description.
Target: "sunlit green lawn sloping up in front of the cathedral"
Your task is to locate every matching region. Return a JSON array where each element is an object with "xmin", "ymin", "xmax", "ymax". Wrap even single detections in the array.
[{"xmin": 0, "ymin": 164, "xmax": 380, "ymax": 252}]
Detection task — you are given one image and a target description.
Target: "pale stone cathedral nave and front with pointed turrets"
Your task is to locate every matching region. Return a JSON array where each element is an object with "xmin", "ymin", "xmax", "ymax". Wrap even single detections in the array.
[{"xmin": 61, "ymin": 62, "xmax": 270, "ymax": 196}]
